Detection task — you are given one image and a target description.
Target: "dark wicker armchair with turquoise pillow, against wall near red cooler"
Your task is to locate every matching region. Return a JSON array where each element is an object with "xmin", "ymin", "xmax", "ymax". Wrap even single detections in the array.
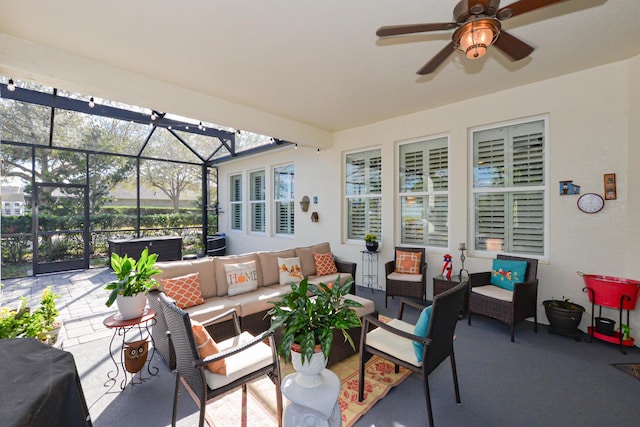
[{"xmin": 468, "ymin": 255, "xmax": 538, "ymax": 342}]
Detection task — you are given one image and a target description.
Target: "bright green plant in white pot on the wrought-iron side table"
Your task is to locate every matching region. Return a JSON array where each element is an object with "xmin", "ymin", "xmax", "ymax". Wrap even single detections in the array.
[{"xmin": 105, "ymin": 248, "xmax": 162, "ymax": 320}]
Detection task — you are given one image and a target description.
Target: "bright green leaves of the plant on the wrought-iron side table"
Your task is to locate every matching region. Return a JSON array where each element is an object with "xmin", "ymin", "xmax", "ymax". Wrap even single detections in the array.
[{"xmin": 105, "ymin": 248, "xmax": 162, "ymax": 307}]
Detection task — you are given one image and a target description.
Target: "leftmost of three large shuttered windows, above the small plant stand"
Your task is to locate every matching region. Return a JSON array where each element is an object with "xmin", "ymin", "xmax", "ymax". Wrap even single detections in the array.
[{"xmin": 345, "ymin": 149, "xmax": 382, "ymax": 240}]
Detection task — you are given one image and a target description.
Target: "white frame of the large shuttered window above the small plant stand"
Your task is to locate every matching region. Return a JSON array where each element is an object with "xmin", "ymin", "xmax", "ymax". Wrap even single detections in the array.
[{"xmin": 342, "ymin": 146, "xmax": 383, "ymax": 244}]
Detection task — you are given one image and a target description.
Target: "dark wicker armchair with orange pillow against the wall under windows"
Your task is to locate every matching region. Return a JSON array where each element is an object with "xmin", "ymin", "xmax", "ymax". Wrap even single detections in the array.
[{"xmin": 384, "ymin": 247, "xmax": 427, "ymax": 307}]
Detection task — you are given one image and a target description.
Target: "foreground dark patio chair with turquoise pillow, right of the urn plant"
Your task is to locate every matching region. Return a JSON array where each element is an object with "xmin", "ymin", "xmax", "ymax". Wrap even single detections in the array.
[{"xmin": 358, "ymin": 281, "xmax": 467, "ymax": 426}]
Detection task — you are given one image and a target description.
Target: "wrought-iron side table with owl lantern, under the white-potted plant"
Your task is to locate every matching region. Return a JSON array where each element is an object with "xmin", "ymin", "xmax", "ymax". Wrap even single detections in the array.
[{"xmin": 102, "ymin": 310, "xmax": 159, "ymax": 390}]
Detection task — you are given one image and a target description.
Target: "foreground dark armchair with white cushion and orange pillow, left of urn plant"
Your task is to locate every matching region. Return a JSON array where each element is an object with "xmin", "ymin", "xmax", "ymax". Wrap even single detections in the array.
[{"xmin": 160, "ymin": 292, "xmax": 282, "ymax": 427}]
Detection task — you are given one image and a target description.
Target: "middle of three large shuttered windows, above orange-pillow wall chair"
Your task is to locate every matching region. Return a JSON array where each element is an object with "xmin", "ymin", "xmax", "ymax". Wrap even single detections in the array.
[{"xmin": 398, "ymin": 137, "xmax": 449, "ymax": 248}]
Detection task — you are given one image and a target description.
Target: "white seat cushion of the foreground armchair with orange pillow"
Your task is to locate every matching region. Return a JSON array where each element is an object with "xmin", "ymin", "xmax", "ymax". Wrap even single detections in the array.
[{"xmin": 204, "ymin": 332, "xmax": 273, "ymax": 389}]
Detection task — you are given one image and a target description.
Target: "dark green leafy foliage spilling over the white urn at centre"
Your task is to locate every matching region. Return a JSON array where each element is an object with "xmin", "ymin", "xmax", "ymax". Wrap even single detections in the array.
[{"xmin": 267, "ymin": 277, "xmax": 362, "ymax": 363}]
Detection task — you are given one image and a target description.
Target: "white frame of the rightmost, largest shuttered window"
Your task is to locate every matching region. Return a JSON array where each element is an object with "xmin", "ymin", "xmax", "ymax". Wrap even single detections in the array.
[{"xmin": 467, "ymin": 114, "xmax": 550, "ymax": 261}]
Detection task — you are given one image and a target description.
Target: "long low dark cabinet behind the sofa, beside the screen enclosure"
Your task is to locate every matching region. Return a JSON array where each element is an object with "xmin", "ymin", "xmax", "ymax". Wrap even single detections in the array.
[{"xmin": 109, "ymin": 236, "xmax": 182, "ymax": 261}]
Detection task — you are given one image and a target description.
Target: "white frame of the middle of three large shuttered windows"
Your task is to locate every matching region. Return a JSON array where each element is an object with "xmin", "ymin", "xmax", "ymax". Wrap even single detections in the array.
[{"xmin": 395, "ymin": 134, "xmax": 451, "ymax": 251}]
